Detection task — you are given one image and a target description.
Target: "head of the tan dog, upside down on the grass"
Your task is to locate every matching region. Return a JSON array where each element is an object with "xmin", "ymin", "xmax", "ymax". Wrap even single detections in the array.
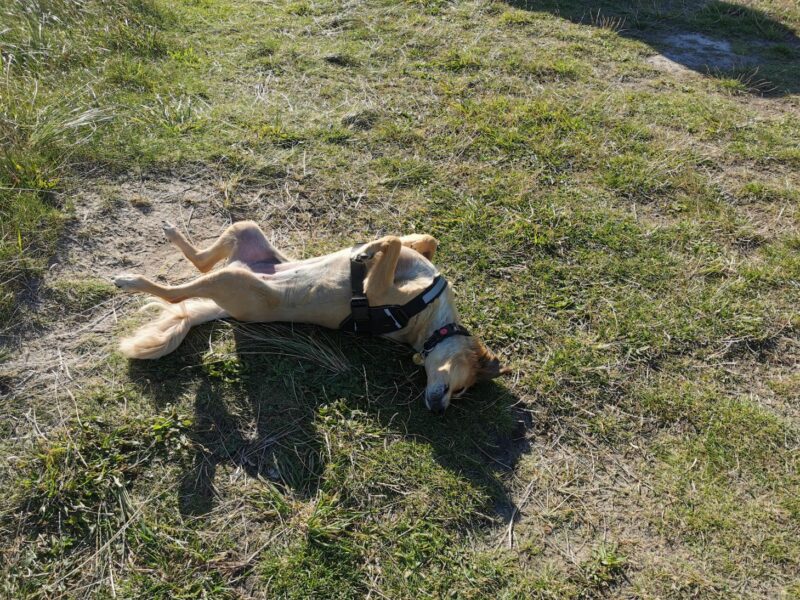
[{"xmin": 425, "ymin": 336, "xmax": 511, "ymax": 413}]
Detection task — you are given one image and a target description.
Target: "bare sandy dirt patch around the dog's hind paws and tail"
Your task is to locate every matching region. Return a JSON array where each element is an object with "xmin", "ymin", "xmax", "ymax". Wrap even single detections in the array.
[{"xmin": 0, "ymin": 180, "xmax": 245, "ymax": 436}]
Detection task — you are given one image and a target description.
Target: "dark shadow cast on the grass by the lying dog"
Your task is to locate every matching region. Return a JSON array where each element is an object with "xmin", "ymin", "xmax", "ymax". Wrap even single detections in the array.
[{"xmin": 129, "ymin": 323, "xmax": 532, "ymax": 522}]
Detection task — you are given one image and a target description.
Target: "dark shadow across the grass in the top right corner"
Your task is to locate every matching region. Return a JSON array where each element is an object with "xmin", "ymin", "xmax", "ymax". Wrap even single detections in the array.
[{"xmin": 506, "ymin": 0, "xmax": 800, "ymax": 96}]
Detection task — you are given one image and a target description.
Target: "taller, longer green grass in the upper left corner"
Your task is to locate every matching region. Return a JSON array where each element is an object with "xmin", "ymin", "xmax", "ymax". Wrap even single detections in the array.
[{"xmin": 0, "ymin": 0, "xmax": 166, "ymax": 322}]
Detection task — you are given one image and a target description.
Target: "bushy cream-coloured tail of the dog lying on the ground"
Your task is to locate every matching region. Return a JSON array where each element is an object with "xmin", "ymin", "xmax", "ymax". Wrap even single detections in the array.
[{"xmin": 119, "ymin": 298, "xmax": 228, "ymax": 359}]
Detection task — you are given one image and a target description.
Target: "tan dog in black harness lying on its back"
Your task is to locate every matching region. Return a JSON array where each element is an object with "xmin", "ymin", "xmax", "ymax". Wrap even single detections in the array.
[{"xmin": 113, "ymin": 221, "xmax": 509, "ymax": 413}]
